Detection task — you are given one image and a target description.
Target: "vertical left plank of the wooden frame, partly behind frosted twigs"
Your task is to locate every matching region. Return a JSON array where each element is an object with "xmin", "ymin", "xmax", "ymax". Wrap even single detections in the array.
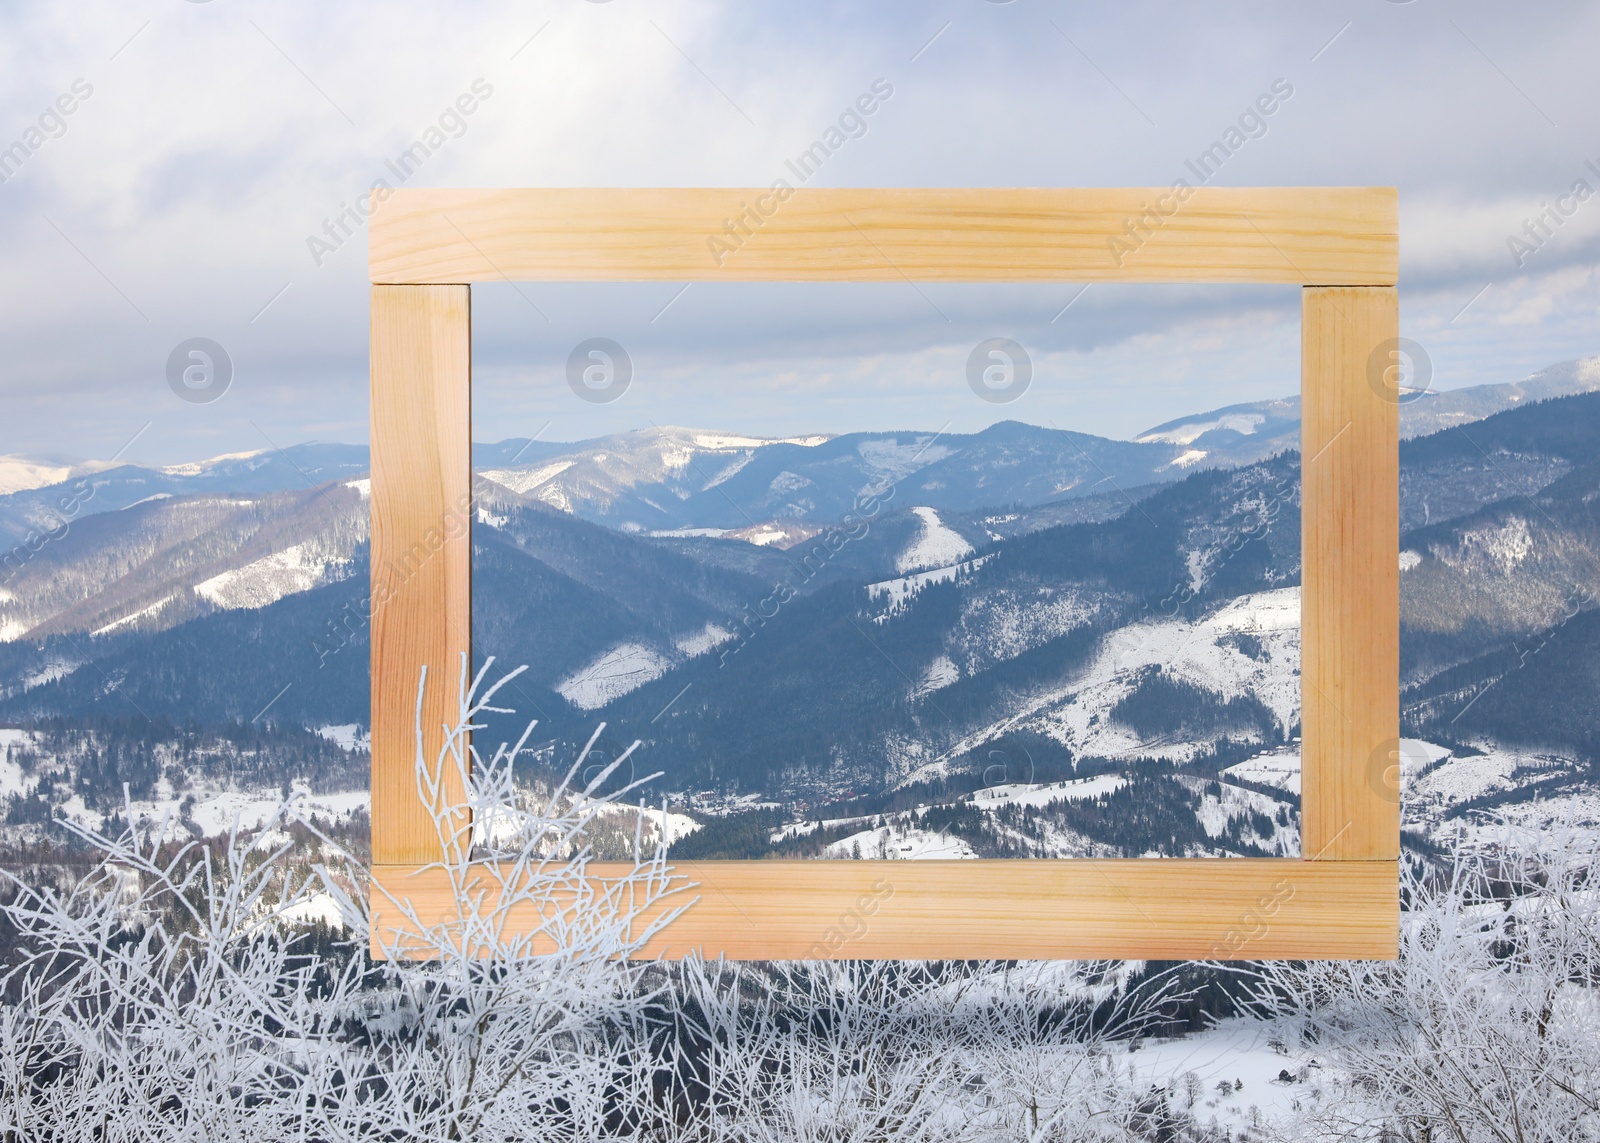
[{"xmin": 371, "ymin": 285, "xmax": 472, "ymax": 863}]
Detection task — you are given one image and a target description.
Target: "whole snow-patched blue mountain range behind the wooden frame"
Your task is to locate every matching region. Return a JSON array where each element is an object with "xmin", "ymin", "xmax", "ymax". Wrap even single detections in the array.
[{"xmin": 0, "ymin": 360, "xmax": 1600, "ymax": 856}]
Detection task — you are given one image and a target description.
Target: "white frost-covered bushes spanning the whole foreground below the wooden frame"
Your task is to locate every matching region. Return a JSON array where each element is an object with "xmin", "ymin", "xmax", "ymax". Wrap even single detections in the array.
[{"xmin": 0, "ymin": 653, "xmax": 1600, "ymax": 1143}]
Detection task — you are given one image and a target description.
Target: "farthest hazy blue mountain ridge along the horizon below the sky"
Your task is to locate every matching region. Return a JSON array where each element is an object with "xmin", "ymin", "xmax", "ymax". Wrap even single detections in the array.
[{"xmin": 0, "ymin": 357, "xmax": 1600, "ymax": 549}]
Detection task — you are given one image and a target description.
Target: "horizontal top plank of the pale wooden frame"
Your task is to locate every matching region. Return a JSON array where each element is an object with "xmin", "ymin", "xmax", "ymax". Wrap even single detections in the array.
[{"xmin": 368, "ymin": 187, "xmax": 1398, "ymax": 285}]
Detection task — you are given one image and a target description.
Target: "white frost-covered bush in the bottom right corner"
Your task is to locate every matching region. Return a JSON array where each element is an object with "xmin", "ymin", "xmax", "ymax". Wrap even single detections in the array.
[{"xmin": 1256, "ymin": 818, "xmax": 1600, "ymax": 1143}]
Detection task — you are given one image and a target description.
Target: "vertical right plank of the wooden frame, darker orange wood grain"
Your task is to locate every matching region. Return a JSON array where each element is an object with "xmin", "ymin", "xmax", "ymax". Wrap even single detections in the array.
[{"xmin": 1301, "ymin": 287, "xmax": 1400, "ymax": 861}]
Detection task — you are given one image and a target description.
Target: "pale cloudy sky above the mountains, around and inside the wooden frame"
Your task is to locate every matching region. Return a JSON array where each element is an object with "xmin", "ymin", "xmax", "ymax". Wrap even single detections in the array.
[{"xmin": 0, "ymin": 0, "xmax": 1600, "ymax": 463}]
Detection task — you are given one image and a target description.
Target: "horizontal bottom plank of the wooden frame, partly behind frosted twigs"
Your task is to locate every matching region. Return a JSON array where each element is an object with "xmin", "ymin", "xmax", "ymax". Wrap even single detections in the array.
[{"xmin": 373, "ymin": 858, "xmax": 1400, "ymax": 959}]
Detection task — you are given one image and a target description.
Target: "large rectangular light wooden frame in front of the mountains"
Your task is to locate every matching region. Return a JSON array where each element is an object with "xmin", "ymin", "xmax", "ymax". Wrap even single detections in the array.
[{"xmin": 370, "ymin": 184, "xmax": 1400, "ymax": 959}]
